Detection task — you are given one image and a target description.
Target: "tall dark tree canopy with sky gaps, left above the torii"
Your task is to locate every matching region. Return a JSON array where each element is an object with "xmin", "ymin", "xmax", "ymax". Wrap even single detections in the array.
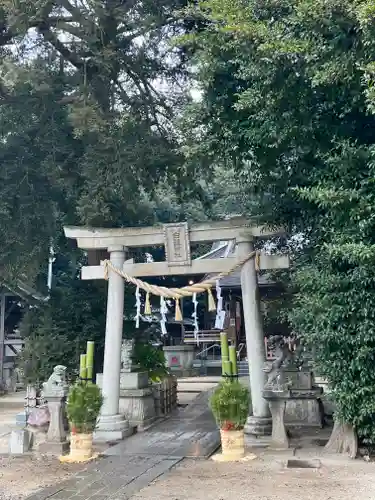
[{"xmin": 0, "ymin": 0, "xmax": 200, "ymax": 281}]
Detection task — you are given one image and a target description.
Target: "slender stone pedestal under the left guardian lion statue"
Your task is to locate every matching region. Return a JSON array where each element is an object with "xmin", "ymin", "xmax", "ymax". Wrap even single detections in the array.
[{"xmin": 38, "ymin": 396, "xmax": 69, "ymax": 456}]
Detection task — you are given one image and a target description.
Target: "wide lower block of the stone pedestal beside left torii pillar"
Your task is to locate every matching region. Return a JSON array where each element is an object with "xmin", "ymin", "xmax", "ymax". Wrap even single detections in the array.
[{"xmin": 119, "ymin": 388, "xmax": 156, "ymax": 430}]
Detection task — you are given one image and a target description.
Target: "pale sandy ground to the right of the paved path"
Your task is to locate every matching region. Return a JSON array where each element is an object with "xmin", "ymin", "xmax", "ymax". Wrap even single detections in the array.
[{"xmin": 131, "ymin": 455, "xmax": 375, "ymax": 500}]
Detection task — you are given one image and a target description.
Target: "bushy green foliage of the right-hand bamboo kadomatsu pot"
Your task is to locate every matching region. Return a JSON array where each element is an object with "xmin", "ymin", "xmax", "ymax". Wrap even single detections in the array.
[{"xmin": 210, "ymin": 380, "xmax": 251, "ymax": 430}]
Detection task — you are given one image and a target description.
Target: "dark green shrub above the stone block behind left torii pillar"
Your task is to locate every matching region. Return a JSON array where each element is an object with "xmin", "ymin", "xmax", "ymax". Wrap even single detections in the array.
[{"xmin": 133, "ymin": 342, "xmax": 169, "ymax": 382}]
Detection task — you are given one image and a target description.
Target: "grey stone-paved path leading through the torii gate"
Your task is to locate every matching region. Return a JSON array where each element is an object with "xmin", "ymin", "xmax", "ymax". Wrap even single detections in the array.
[{"xmin": 27, "ymin": 391, "xmax": 220, "ymax": 500}]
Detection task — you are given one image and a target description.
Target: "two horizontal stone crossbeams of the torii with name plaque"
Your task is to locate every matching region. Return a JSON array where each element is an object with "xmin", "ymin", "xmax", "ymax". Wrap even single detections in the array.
[{"xmin": 64, "ymin": 217, "xmax": 289, "ymax": 280}]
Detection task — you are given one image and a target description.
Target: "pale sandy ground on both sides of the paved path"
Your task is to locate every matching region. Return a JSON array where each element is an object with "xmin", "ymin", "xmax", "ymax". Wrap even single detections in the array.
[{"xmin": 0, "ymin": 451, "xmax": 375, "ymax": 500}]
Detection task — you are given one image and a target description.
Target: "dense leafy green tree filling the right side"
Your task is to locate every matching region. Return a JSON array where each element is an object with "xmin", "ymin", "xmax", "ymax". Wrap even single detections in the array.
[{"xmin": 181, "ymin": 0, "xmax": 375, "ymax": 441}]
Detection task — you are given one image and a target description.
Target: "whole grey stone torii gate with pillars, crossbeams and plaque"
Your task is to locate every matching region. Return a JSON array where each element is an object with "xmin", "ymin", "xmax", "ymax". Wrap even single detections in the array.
[{"xmin": 64, "ymin": 218, "xmax": 289, "ymax": 441}]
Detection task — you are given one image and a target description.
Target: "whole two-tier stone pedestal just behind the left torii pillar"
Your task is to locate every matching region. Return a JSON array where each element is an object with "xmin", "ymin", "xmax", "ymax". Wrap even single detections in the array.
[{"xmin": 96, "ymin": 372, "xmax": 156, "ymax": 430}]
